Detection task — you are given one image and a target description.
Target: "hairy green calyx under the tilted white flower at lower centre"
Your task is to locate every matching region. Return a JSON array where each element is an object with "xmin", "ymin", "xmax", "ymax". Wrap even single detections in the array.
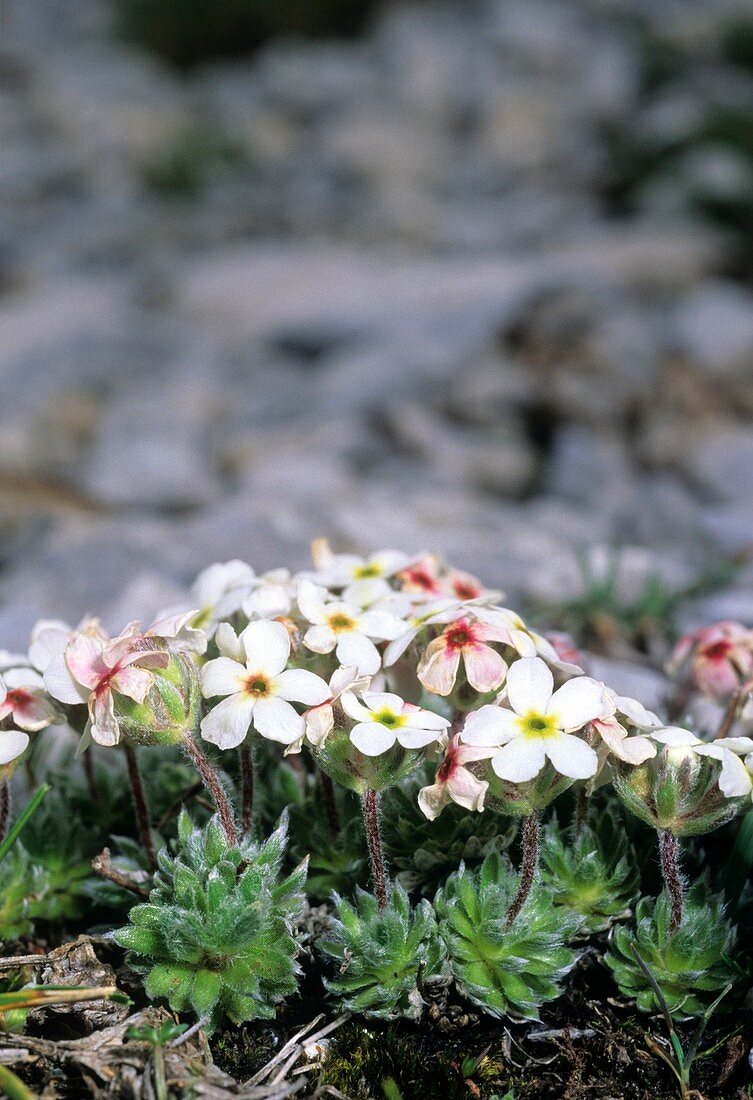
[{"xmin": 311, "ymin": 722, "xmax": 427, "ymax": 794}]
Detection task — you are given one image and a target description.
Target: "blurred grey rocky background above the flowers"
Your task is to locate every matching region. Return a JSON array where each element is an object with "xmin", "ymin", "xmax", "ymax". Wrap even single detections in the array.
[{"xmin": 0, "ymin": 0, "xmax": 753, "ymax": 647}]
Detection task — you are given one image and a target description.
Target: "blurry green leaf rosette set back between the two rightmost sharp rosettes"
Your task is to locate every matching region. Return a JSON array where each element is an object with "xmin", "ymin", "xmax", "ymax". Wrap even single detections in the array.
[{"xmin": 540, "ymin": 811, "xmax": 639, "ymax": 932}]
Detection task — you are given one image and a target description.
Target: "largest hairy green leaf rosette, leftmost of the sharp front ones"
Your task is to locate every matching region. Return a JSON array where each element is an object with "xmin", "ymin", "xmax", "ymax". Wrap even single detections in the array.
[{"xmin": 113, "ymin": 811, "xmax": 306, "ymax": 1031}]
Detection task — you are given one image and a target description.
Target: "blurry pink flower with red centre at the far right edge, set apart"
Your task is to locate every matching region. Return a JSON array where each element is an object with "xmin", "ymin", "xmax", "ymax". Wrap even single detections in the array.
[{"xmin": 668, "ymin": 622, "xmax": 753, "ymax": 702}]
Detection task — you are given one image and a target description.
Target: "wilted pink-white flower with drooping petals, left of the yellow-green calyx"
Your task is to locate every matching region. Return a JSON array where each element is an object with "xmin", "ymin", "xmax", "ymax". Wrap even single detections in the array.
[{"xmin": 44, "ymin": 624, "xmax": 169, "ymax": 745}]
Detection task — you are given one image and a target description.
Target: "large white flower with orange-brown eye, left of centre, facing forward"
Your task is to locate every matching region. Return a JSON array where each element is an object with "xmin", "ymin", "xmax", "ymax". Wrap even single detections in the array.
[{"xmin": 201, "ymin": 619, "xmax": 330, "ymax": 749}]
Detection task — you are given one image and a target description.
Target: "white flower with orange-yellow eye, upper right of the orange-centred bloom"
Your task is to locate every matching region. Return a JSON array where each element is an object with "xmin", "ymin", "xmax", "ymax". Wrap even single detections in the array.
[{"xmin": 298, "ymin": 580, "xmax": 405, "ymax": 675}]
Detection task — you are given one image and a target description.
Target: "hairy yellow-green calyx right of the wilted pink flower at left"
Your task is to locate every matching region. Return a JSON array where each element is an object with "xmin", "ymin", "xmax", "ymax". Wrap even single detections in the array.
[{"xmin": 112, "ymin": 652, "xmax": 201, "ymax": 745}]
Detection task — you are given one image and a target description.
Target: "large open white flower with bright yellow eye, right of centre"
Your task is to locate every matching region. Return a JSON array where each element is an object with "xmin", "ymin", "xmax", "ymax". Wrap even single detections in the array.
[{"xmin": 462, "ymin": 657, "xmax": 611, "ymax": 783}]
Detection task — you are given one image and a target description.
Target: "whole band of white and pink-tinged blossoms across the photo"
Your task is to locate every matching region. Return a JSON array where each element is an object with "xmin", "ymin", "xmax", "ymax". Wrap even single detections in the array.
[{"xmin": 0, "ymin": 539, "xmax": 753, "ymax": 817}]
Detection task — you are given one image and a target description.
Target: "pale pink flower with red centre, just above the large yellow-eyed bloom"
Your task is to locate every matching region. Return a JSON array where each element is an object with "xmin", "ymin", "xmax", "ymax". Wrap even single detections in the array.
[{"xmin": 417, "ymin": 613, "xmax": 509, "ymax": 695}]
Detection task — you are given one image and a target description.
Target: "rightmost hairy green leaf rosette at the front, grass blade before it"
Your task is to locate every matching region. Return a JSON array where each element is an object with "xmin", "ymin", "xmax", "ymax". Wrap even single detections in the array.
[{"xmin": 605, "ymin": 880, "xmax": 744, "ymax": 1021}]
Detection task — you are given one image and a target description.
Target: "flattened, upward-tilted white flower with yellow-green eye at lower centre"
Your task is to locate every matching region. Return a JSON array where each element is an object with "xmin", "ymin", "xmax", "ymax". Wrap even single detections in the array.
[{"xmin": 340, "ymin": 692, "xmax": 450, "ymax": 756}]
